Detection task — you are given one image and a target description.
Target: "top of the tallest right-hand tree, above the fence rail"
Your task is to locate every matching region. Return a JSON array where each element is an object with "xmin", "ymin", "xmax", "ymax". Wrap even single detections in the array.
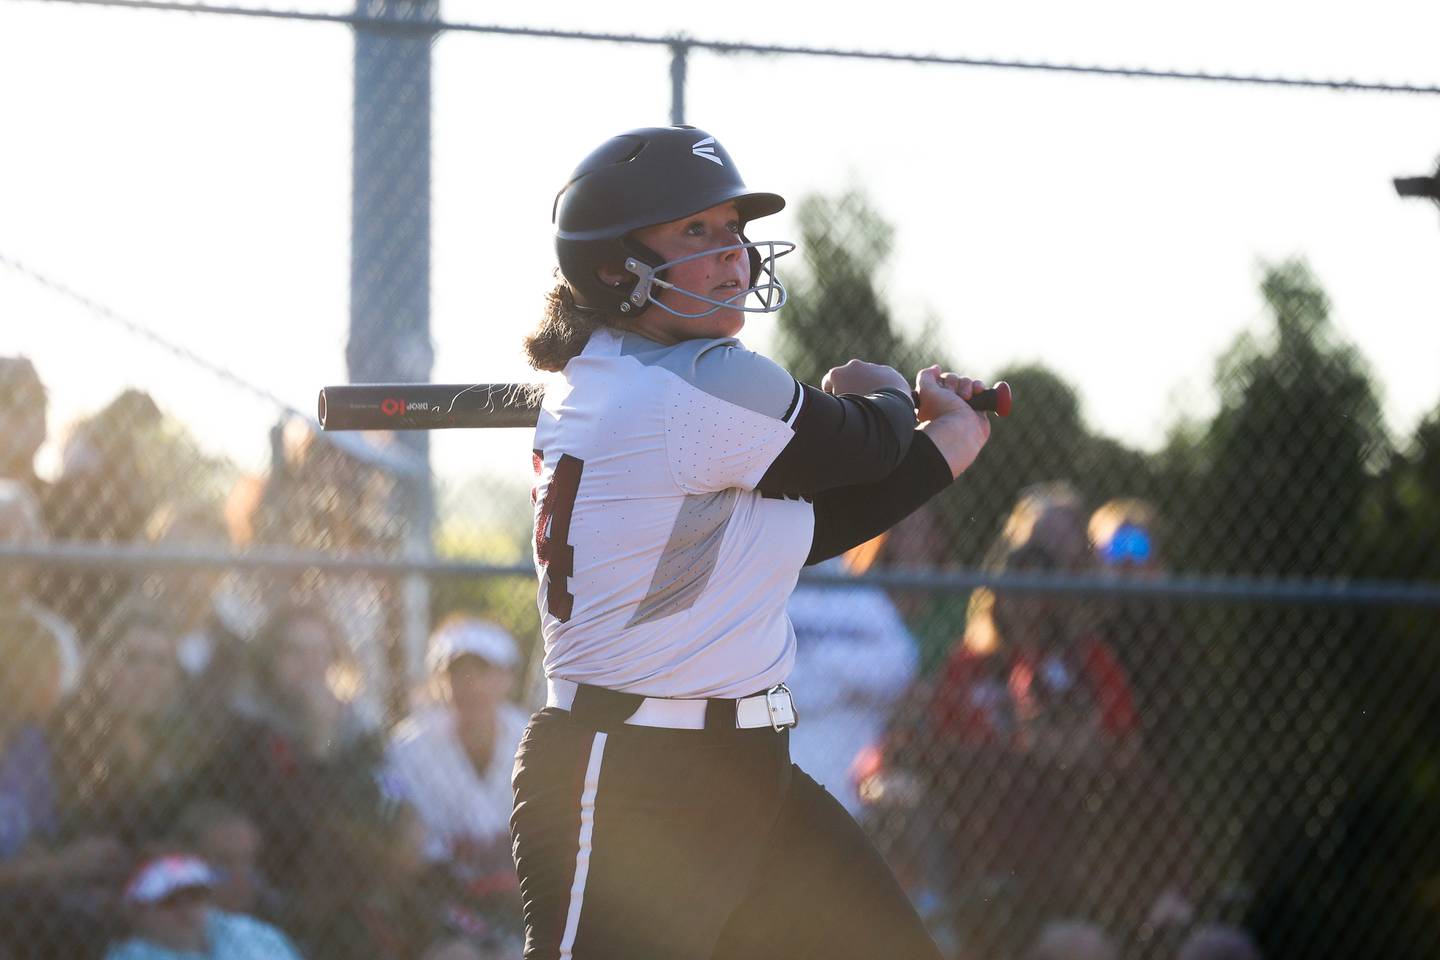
[{"xmin": 1178, "ymin": 262, "xmax": 1390, "ymax": 576}]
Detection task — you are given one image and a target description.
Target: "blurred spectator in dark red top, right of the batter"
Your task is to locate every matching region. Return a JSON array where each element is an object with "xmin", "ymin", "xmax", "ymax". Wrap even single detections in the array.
[{"xmin": 912, "ymin": 486, "xmax": 1164, "ymax": 950}]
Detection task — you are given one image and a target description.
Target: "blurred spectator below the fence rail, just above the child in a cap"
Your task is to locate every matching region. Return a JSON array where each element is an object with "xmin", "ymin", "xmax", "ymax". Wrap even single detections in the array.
[{"xmin": 56, "ymin": 596, "xmax": 202, "ymax": 842}]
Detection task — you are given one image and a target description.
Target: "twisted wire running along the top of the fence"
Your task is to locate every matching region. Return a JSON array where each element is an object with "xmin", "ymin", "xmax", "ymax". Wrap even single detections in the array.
[{"xmin": 11, "ymin": 0, "xmax": 1440, "ymax": 96}]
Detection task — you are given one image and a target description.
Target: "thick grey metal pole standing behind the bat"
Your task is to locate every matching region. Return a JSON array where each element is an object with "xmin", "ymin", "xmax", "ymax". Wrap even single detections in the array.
[{"xmin": 346, "ymin": 0, "xmax": 439, "ymax": 718}]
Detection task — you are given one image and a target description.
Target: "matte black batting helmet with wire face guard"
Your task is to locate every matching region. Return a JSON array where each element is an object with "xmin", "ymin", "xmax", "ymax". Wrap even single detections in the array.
[{"xmin": 552, "ymin": 127, "xmax": 795, "ymax": 317}]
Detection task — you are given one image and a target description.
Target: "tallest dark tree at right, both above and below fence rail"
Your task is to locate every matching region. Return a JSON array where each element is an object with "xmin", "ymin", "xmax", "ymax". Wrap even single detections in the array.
[{"xmin": 1159, "ymin": 261, "xmax": 1436, "ymax": 956}]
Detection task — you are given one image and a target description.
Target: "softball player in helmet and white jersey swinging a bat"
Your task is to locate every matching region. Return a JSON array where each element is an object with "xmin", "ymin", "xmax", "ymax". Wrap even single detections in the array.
[{"xmin": 511, "ymin": 127, "xmax": 989, "ymax": 960}]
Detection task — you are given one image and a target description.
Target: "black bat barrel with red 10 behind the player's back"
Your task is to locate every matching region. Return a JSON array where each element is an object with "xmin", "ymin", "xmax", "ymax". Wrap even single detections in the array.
[{"xmin": 320, "ymin": 383, "xmax": 544, "ymax": 430}]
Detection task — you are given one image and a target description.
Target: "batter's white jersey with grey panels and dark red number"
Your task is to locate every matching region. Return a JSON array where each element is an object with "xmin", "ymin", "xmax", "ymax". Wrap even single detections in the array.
[{"xmin": 534, "ymin": 328, "xmax": 815, "ymax": 698}]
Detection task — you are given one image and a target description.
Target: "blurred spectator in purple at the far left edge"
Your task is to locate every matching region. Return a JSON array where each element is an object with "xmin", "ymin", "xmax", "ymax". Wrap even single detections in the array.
[{"xmin": 0, "ymin": 610, "xmax": 124, "ymax": 957}]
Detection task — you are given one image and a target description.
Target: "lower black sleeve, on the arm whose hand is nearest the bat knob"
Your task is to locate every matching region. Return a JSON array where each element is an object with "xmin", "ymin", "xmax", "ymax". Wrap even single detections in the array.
[{"xmin": 805, "ymin": 430, "xmax": 955, "ymax": 566}]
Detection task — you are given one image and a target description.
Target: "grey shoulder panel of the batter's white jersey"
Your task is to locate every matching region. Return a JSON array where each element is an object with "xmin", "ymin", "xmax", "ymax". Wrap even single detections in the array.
[{"xmin": 621, "ymin": 334, "xmax": 801, "ymax": 420}]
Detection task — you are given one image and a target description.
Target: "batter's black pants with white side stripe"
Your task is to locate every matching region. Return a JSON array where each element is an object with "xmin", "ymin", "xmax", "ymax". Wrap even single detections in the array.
[{"xmin": 510, "ymin": 701, "xmax": 940, "ymax": 960}]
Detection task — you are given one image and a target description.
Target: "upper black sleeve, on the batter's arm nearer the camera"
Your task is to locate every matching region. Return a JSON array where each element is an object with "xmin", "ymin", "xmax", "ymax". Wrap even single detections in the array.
[{"xmin": 756, "ymin": 383, "xmax": 914, "ymax": 497}]
